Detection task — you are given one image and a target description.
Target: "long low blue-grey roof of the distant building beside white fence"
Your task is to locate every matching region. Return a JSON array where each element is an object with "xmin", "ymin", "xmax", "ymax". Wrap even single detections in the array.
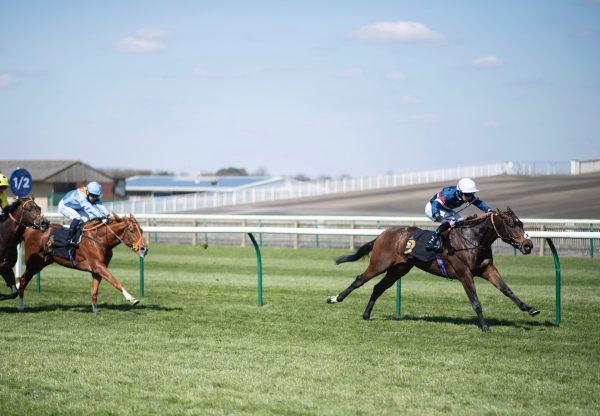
[{"xmin": 125, "ymin": 175, "xmax": 285, "ymax": 192}]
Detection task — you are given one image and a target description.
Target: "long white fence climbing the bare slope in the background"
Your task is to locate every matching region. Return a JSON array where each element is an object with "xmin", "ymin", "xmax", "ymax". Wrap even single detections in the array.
[{"xmin": 88, "ymin": 161, "xmax": 570, "ymax": 214}]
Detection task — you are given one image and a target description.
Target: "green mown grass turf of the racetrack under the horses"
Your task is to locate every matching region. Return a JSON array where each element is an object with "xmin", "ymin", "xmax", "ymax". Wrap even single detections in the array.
[{"xmin": 0, "ymin": 245, "xmax": 600, "ymax": 415}]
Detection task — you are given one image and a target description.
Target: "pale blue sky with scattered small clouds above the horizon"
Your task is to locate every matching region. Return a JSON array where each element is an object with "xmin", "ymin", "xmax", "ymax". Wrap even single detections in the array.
[{"xmin": 0, "ymin": 0, "xmax": 600, "ymax": 178}]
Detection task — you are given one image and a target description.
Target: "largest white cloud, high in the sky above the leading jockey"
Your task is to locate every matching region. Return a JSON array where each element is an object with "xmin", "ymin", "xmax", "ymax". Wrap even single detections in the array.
[{"xmin": 354, "ymin": 20, "xmax": 447, "ymax": 43}]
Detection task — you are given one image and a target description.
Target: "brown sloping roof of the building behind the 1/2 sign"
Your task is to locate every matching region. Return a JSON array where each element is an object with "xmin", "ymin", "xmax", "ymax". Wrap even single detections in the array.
[{"xmin": 0, "ymin": 160, "xmax": 112, "ymax": 182}]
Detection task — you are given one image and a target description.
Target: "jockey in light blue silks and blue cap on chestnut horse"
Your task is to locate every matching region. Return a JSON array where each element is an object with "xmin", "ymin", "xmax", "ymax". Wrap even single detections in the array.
[{"xmin": 58, "ymin": 182, "xmax": 110, "ymax": 247}]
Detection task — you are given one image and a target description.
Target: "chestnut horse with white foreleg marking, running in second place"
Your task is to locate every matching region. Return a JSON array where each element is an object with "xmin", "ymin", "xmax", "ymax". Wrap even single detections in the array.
[{"xmin": 19, "ymin": 213, "xmax": 148, "ymax": 313}]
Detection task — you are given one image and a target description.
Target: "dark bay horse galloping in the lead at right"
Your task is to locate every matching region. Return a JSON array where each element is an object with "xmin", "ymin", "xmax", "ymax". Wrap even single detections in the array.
[{"xmin": 327, "ymin": 207, "xmax": 540, "ymax": 332}]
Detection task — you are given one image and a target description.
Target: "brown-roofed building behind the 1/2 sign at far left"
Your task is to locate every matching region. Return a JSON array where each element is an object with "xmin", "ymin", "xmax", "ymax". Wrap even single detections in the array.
[{"xmin": 0, "ymin": 160, "xmax": 114, "ymax": 210}]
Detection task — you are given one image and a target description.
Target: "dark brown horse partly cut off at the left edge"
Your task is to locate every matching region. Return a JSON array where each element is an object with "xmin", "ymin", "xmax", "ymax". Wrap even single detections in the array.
[{"xmin": 0, "ymin": 198, "xmax": 48, "ymax": 300}]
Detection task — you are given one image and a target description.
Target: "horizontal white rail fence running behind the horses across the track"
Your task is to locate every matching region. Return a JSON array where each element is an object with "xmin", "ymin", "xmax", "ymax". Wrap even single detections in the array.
[{"xmin": 46, "ymin": 213, "xmax": 600, "ymax": 257}]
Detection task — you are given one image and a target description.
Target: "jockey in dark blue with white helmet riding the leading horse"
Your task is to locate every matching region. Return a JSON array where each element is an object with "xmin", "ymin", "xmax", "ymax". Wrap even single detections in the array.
[{"xmin": 425, "ymin": 178, "xmax": 492, "ymax": 251}]
